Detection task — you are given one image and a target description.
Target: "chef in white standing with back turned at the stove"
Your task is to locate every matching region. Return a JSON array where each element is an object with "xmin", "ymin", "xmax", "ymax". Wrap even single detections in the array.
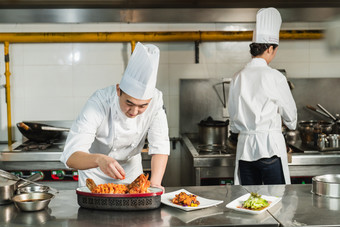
[{"xmin": 228, "ymin": 8, "xmax": 297, "ymax": 185}]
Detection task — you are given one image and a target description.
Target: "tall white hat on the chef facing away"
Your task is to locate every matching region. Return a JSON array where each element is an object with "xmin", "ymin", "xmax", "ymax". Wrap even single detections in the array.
[{"xmin": 253, "ymin": 7, "xmax": 282, "ymax": 44}]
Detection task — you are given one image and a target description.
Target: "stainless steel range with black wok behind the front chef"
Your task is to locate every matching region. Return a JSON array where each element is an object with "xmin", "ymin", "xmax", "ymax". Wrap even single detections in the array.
[{"xmin": 0, "ymin": 121, "xmax": 151, "ymax": 189}]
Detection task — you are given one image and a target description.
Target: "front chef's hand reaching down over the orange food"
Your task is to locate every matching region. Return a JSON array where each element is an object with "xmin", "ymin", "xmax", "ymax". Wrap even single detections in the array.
[{"xmin": 98, "ymin": 155, "xmax": 125, "ymax": 180}]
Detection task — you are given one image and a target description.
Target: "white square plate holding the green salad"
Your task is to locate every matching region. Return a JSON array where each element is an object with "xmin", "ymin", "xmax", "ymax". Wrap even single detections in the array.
[{"xmin": 226, "ymin": 193, "xmax": 281, "ymax": 214}]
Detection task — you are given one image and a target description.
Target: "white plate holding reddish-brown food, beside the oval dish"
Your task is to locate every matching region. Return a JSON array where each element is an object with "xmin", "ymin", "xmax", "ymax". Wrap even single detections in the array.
[{"xmin": 161, "ymin": 189, "xmax": 223, "ymax": 211}]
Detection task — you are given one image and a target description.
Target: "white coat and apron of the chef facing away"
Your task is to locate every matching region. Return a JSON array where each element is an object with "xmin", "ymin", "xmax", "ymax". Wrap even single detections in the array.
[{"xmin": 228, "ymin": 58, "xmax": 297, "ymax": 184}]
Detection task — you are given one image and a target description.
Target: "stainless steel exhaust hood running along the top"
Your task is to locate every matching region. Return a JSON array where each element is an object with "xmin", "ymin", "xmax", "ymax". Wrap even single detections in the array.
[{"xmin": 0, "ymin": 0, "xmax": 340, "ymax": 23}]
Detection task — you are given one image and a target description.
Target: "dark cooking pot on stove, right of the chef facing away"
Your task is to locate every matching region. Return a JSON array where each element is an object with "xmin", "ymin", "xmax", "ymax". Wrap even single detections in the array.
[{"xmin": 298, "ymin": 120, "xmax": 334, "ymax": 145}]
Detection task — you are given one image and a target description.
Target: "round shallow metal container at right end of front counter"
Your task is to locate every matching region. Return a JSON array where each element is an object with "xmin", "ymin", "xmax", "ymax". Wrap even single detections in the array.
[{"xmin": 312, "ymin": 174, "xmax": 340, "ymax": 198}]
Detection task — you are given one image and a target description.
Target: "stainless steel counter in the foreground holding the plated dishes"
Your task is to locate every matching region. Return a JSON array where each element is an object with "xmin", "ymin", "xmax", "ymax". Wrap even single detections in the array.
[{"xmin": 0, "ymin": 185, "xmax": 340, "ymax": 227}]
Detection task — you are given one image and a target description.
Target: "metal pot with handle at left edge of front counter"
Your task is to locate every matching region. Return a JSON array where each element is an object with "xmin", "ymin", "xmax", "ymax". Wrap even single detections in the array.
[{"xmin": 0, "ymin": 173, "xmax": 41, "ymax": 205}]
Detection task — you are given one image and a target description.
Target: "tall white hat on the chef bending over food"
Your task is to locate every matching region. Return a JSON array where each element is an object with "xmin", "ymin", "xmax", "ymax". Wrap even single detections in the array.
[{"xmin": 119, "ymin": 42, "xmax": 159, "ymax": 100}]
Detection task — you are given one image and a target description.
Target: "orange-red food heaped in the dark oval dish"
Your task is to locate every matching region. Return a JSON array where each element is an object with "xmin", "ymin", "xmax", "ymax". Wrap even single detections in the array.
[{"xmin": 86, "ymin": 174, "xmax": 150, "ymax": 194}]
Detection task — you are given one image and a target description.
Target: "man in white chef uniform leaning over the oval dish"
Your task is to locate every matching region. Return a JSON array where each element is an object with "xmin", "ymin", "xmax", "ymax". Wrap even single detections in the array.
[{"xmin": 60, "ymin": 43, "xmax": 170, "ymax": 189}]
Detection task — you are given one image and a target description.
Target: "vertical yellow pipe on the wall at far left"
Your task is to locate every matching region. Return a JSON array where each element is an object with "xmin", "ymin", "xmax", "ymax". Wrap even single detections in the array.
[{"xmin": 5, "ymin": 42, "xmax": 12, "ymax": 146}]
